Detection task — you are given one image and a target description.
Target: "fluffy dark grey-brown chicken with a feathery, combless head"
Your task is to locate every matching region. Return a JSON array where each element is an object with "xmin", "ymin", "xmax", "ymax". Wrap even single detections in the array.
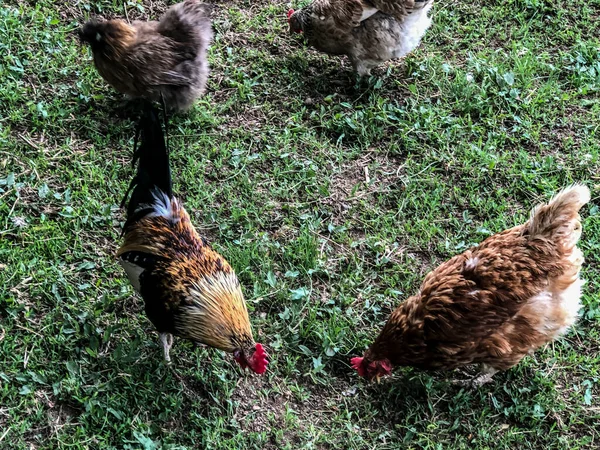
[{"xmin": 79, "ymin": 0, "xmax": 213, "ymax": 111}]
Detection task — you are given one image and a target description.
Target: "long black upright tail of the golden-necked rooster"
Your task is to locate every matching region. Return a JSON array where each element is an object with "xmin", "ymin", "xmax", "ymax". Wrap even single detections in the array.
[{"xmin": 121, "ymin": 103, "xmax": 173, "ymax": 233}]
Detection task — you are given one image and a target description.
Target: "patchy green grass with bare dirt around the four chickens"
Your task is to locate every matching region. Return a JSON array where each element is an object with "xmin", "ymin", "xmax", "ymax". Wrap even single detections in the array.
[{"xmin": 0, "ymin": 0, "xmax": 600, "ymax": 449}]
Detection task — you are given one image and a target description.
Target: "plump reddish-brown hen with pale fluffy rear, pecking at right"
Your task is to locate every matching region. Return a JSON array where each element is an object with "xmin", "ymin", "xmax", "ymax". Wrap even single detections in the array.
[{"xmin": 351, "ymin": 185, "xmax": 590, "ymax": 385}]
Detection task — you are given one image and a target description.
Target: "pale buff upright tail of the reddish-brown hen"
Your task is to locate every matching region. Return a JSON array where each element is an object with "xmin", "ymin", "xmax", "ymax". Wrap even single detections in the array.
[{"xmin": 529, "ymin": 184, "xmax": 590, "ymax": 251}]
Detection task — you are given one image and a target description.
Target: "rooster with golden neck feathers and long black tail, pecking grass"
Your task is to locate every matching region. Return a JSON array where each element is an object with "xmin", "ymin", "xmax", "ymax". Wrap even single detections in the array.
[{"xmin": 117, "ymin": 103, "xmax": 267, "ymax": 374}]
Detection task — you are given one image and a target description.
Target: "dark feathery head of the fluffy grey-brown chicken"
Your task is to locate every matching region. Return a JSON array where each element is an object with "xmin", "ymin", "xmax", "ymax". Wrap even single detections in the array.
[{"xmin": 78, "ymin": 19, "xmax": 135, "ymax": 52}]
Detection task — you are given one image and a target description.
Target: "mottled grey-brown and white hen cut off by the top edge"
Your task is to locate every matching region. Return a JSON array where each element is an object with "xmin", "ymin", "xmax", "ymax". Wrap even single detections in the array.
[{"xmin": 288, "ymin": 0, "xmax": 433, "ymax": 76}]
